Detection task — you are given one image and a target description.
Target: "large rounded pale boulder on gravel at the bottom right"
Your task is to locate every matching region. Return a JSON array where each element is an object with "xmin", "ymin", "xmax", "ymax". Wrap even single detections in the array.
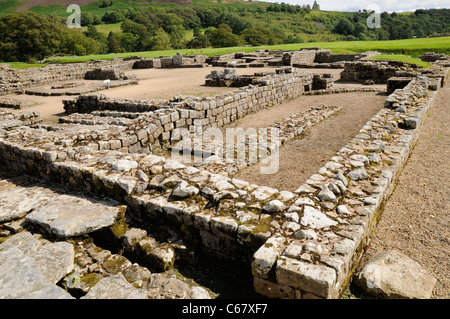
[{"xmin": 355, "ymin": 250, "xmax": 437, "ymax": 299}]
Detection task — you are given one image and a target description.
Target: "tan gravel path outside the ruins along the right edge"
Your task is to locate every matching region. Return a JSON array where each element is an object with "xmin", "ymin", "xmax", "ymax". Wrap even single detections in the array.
[{"xmin": 361, "ymin": 82, "xmax": 450, "ymax": 299}]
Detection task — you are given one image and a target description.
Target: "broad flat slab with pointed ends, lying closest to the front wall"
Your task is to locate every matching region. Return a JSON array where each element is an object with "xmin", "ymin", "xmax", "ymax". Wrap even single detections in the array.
[{"xmin": 26, "ymin": 195, "xmax": 125, "ymax": 238}]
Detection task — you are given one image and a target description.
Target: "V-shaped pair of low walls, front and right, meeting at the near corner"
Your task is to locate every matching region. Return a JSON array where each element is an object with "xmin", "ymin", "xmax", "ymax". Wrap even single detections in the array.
[{"xmin": 0, "ymin": 73, "xmax": 442, "ymax": 298}]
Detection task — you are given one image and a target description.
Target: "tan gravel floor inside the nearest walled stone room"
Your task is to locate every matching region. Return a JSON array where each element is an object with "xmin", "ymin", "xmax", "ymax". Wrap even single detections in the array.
[{"xmin": 235, "ymin": 92, "xmax": 386, "ymax": 191}]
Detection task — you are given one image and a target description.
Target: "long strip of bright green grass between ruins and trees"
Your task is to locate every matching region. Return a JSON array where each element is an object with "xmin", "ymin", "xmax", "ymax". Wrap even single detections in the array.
[{"xmin": 41, "ymin": 37, "xmax": 450, "ymax": 63}]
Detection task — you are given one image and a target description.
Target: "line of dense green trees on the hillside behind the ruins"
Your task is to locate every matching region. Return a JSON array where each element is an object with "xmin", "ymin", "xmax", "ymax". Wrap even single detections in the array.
[{"xmin": 0, "ymin": 4, "xmax": 450, "ymax": 62}]
